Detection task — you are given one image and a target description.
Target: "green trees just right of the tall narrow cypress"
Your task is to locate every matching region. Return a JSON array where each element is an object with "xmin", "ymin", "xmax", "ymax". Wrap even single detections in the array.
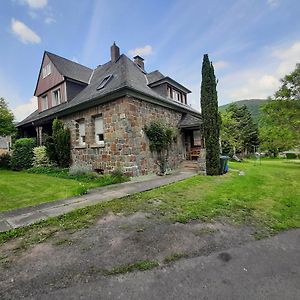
[{"xmin": 221, "ymin": 103, "xmax": 259, "ymax": 155}]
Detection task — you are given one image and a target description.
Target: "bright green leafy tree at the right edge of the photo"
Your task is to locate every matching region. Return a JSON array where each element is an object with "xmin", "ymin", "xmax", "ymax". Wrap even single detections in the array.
[{"xmin": 260, "ymin": 64, "xmax": 300, "ymax": 156}]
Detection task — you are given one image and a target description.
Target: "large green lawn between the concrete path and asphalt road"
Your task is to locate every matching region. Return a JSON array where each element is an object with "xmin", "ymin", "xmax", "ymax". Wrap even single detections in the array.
[{"xmin": 0, "ymin": 160, "xmax": 300, "ymax": 244}]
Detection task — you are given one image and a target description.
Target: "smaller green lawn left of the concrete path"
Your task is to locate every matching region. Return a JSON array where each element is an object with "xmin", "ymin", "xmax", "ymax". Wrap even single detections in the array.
[{"xmin": 0, "ymin": 170, "xmax": 124, "ymax": 212}]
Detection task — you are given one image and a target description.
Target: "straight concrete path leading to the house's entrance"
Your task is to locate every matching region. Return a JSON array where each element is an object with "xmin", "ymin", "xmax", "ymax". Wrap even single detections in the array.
[{"xmin": 0, "ymin": 171, "xmax": 196, "ymax": 232}]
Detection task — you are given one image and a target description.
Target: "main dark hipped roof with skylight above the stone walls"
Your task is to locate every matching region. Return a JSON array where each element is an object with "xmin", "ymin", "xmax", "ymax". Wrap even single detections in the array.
[{"xmin": 17, "ymin": 54, "xmax": 200, "ymax": 127}]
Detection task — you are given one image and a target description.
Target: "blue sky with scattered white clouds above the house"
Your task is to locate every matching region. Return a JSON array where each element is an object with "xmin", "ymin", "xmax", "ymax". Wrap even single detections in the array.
[{"xmin": 0, "ymin": 0, "xmax": 300, "ymax": 121}]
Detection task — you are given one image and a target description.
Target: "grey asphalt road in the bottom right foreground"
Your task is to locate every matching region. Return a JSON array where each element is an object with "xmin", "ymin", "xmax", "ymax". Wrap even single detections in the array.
[{"xmin": 36, "ymin": 229, "xmax": 300, "ymax": 300}]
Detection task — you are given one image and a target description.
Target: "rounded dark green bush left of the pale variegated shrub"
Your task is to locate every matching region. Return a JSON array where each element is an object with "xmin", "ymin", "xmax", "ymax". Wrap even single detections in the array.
[{"xmin": 11, "ymin": 138, "xmax": 36, "ymax": 170}]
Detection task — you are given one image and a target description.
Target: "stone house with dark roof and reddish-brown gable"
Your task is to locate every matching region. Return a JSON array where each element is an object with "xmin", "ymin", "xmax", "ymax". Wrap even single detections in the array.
[{"xmin": 17, "ymin": 43, "xmax": 203, "ymax": 175}]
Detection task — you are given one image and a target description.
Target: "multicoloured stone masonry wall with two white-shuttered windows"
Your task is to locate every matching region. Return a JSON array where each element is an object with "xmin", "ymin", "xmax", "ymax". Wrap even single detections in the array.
[{"xmin": 63, "ymin": 97, "xmax": 184, "ymax": 176}]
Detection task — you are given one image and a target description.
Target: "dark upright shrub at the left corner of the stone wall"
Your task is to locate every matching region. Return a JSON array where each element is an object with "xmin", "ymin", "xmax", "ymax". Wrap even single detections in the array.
[{"xmin": 52, "ymin": 118, "xmax": 71, "ymax": 168}]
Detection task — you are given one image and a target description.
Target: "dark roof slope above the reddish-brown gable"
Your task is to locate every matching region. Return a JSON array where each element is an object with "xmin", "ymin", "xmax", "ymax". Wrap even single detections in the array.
[{"xmin": 45, "ymin": 51, "xmax": 93, "ymax": 83}]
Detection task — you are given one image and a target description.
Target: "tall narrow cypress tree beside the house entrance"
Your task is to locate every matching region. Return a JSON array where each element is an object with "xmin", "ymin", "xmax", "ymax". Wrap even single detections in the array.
[{"xmin": 201, "ymin": 54, "xmax": 220, "ymax": 175}]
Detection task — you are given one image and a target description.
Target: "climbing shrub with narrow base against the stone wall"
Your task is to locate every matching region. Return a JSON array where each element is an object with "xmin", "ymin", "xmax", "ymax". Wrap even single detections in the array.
[{"xmin": 144, "ymin": 120, "xmax": 176, "ymax": 175}]
